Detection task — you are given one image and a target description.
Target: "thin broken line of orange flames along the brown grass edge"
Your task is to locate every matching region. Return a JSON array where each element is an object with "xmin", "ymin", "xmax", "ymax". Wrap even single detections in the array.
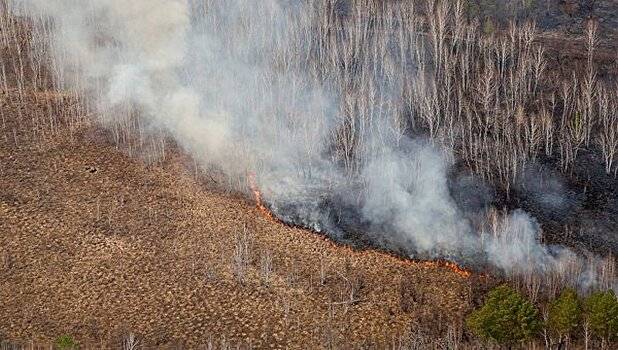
[{"xmin": 243, "ymin": 173, "xmax": 472, "ymax": 278}]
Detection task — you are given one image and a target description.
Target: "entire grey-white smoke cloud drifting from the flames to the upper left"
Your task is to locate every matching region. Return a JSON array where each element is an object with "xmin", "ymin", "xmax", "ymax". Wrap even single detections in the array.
[{"xmin": 12, "ymin": 0, "xmax": 612, "ymax": 290}]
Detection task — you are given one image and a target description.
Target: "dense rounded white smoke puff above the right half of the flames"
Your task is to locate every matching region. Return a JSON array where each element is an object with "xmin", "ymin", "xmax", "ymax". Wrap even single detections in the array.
[{"xmin": 361, "ymin": 143, "xmax": 470, "ymax": 254}]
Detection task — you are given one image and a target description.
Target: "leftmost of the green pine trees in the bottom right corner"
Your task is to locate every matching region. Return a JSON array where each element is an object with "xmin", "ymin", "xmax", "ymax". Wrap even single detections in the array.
[{"xmin": 467, "ymin": 285, "xmax": 541, "ymax": 345}]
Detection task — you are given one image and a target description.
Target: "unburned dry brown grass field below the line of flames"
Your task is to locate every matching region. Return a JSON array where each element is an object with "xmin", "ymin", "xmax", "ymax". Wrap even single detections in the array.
[{"xmin": 0, "ymin": 90, "xmax": 482, "ymax": 349}]
